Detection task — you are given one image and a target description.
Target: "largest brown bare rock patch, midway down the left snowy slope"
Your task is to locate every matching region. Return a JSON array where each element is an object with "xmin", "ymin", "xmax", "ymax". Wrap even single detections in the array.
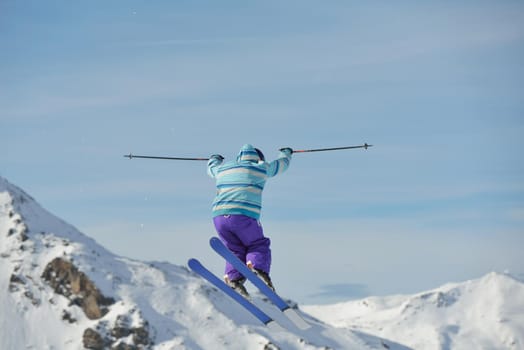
[{"xmin": 42, "ymin": 258, "xmax": 114, "ymax": 320}]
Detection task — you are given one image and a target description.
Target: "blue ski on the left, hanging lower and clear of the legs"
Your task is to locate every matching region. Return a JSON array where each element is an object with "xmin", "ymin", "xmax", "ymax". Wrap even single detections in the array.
[{"xmin": 187, "ymin": 259, "xmax": 280, "ymax": 329}]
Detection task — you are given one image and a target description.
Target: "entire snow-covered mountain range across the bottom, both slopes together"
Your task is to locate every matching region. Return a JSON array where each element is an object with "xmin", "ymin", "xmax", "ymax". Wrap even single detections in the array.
[{"xmin": 0, "ymin": 177, "xmax": 524, "ymax": 350}]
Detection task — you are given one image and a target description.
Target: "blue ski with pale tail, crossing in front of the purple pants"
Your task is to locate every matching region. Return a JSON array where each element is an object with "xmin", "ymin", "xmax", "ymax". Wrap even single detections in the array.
[{"xmin": 209, "ymin": 237, "xmax": 311, "ymax": 330}]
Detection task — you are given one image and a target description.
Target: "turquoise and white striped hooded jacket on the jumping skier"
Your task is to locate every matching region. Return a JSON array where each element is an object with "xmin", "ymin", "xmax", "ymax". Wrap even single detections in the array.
[{"xmin": 207, "ymin": 144, "xmax": 291, "ymax": 219}]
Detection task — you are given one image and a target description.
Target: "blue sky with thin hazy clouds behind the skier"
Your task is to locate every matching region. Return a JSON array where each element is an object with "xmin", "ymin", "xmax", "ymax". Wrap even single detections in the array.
[{"xmin": 0, "ymin": 0, "xmax": 524, "ymax": 303}]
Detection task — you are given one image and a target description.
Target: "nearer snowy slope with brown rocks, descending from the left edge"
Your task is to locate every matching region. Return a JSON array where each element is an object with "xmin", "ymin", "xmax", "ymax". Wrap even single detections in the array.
[{"xmin": 0, "ymin": 177, "xmax": 398, "ymax": 350}]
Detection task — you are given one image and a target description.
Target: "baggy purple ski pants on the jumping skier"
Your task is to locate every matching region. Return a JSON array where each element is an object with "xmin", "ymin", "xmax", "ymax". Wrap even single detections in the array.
[{"xmin": 213, "ymin": 215, "xmax": 271, "ymax": 281}]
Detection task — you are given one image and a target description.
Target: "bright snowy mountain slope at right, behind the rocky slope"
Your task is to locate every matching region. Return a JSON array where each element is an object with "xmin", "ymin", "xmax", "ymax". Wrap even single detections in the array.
[{"xmin": 303, "ymin": 273, "xmax": 524, "ymax": 350}]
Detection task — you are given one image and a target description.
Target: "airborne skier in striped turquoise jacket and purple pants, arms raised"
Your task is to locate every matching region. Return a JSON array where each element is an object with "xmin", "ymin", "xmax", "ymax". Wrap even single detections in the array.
[{"xmin": 207, "ymin": 144, "xmax": 293, "ymax": 297}]
